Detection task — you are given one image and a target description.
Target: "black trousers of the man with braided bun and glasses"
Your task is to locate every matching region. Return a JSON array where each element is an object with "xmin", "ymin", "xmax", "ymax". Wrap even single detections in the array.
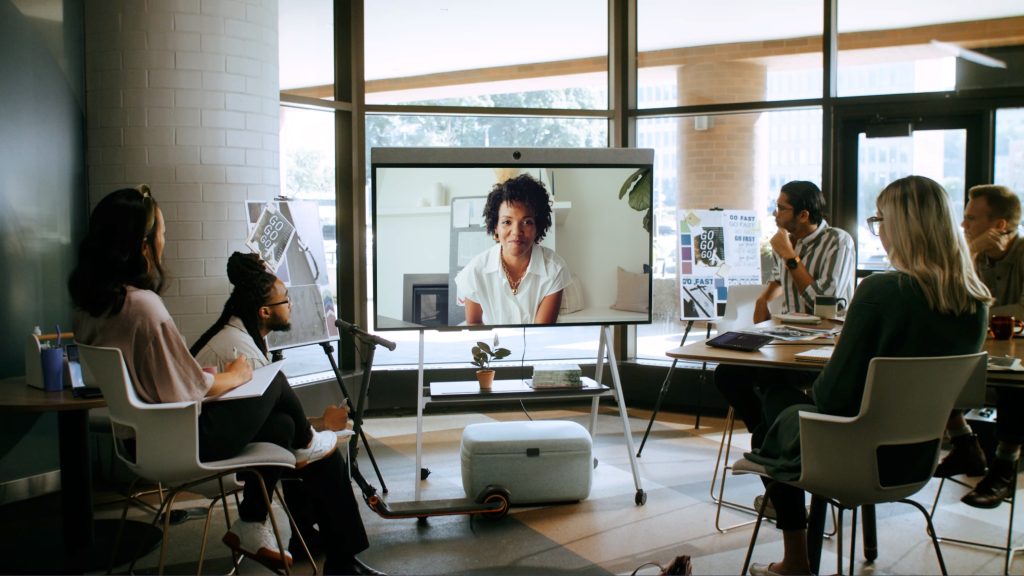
[{"xmin": 282, "ymin": 448, "xmax": 370, "ymax": 573}]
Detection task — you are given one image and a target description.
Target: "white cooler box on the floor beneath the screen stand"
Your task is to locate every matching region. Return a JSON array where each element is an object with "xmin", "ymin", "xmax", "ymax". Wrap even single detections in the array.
[{"xmin": 461, "ymin": 420, "xmax": 594, "ymax": 504}]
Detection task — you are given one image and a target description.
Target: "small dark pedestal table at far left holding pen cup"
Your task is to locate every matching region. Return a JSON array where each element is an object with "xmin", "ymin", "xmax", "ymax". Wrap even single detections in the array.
[{"xmin": 0, "ymin": 377, "xmax": 161, "ymax": 573}]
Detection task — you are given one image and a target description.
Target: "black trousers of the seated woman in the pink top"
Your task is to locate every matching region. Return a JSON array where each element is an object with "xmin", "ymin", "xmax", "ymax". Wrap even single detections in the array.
[{"xmin": 199, "ymin": 373, "xmax": 312, "ymax": 522}]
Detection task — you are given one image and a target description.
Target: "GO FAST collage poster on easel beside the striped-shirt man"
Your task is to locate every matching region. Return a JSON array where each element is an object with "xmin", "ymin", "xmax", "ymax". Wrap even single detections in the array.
[{"xmin": 677, "ymin": 209, "xmax": 761, "ymax": 320}]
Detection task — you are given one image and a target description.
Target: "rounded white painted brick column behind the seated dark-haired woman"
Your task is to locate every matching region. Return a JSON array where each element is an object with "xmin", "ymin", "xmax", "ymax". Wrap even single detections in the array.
[{"xmin": 85, "ymin": 0, "xmax": 280, "ymax": 341}]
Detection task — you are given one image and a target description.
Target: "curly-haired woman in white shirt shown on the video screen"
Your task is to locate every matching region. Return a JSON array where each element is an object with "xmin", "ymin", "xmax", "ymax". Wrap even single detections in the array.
[{"xmin": 455, "ymin": 174, "xmax": 571, "ymax": 325}]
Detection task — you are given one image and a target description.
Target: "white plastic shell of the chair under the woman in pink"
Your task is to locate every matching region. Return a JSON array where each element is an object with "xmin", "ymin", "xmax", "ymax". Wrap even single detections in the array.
[{"xmin": 79, "ymin": 344, "xmax": 209, "ymax": 484}]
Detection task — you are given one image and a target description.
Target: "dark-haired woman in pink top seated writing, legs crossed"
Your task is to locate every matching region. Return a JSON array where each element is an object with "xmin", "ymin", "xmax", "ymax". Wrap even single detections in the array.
[{"xmin": 68, "ymin": 186, "xmax": 338, "ymax": 567}]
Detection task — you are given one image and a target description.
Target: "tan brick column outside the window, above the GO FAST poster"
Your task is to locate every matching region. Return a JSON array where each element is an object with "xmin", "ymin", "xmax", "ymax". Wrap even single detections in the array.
[{"xmin": 679, "ymin": 61, "xmax": 767, "ymax": 210}]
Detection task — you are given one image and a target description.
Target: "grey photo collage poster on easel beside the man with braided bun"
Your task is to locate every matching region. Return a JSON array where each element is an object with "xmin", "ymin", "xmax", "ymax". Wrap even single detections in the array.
[{"xmin": 246, "ymin": 200, "xmax": 338, "ymax": 349}]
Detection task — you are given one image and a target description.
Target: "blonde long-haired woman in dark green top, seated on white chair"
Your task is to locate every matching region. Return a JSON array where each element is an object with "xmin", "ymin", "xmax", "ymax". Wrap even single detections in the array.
[{"xmin": 748, "ymin": 176, "xmax": 991, "ymax": 576}]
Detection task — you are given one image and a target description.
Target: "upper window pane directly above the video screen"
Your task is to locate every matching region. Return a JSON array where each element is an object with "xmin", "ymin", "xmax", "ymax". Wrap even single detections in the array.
[{"xmin": 366, "ymin": 0, "xmax": 608, "ymax": 107}]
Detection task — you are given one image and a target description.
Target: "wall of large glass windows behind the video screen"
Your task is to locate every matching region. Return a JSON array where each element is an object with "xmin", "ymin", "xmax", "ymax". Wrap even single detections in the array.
[{"xmin": 280, "ymin": 0, "xmax": 1024, "ymax": 373}]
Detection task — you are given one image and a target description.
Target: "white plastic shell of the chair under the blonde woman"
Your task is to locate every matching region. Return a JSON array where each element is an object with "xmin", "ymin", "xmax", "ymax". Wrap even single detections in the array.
[{"xmin": 795, "ymin": 353, "xmax": 987, "ymax": 506}]
